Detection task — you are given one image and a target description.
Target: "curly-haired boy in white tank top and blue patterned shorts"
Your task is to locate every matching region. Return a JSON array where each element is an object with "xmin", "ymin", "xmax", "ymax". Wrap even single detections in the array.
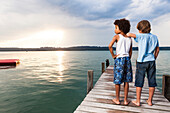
[{"xmin": 109, "ymin": 19, "xmax": 133, "ymax": 105}]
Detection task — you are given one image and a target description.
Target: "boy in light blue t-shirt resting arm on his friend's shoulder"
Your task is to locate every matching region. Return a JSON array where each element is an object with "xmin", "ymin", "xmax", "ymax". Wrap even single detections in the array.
[{"xmin": 127, "ymin": 20, "xmax": 159, "ymax": 106}]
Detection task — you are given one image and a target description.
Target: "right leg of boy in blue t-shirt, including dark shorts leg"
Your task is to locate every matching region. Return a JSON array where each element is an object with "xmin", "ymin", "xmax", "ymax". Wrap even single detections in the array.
[{"xmin": 147, "ymin": 61, "xmax": 157, "ymax": 106}]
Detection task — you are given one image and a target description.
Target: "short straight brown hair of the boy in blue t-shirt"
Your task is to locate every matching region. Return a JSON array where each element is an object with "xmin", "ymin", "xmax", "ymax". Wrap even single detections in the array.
[{"xmin": 137, "ymin": 20, "xmax": 151, "ymax": 33}]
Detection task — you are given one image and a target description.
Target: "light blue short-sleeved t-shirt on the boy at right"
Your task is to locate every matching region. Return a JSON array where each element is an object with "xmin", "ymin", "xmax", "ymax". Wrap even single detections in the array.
[{"xmin": 135, "ymin": 33, "xmax": 159, "ymax": 62}]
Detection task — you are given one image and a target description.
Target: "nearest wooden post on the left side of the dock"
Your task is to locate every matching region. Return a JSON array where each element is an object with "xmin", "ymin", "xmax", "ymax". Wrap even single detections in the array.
[{"xmin": 87, "ymin": 70, "xmax": 93, "ymax": 94}]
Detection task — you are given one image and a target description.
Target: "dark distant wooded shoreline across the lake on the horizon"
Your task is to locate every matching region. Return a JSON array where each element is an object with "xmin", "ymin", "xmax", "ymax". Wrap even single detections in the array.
[{"xmin": 0, "ymin": 46, "xmax": 170, "ymax": 52}]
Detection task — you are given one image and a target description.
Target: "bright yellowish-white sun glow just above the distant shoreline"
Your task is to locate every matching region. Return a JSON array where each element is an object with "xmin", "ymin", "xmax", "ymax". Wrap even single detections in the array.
[{"xmin": 0, "ymin": 30, "xmax": 64, "ymax": 48}]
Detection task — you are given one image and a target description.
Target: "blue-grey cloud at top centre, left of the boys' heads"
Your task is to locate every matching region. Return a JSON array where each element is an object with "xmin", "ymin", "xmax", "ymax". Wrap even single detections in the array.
[{"xmin": 44, "ymin": 0, "xmax": 130, "ymax": 21}]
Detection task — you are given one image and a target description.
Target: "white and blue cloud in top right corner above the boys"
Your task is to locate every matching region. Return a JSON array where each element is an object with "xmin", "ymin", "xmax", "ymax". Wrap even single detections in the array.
[{"xmin": 120, "ymin": 0, "xmax": 170, "ymax": 21}]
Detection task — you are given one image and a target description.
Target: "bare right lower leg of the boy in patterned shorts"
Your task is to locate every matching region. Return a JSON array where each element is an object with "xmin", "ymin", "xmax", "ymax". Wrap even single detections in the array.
[{"xmin": 124, "ymin": 82, "xmax": 129, "ymax": 105}]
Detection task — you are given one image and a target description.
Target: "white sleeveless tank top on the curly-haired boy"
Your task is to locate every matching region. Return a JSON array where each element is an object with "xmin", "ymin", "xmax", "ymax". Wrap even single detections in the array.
[{"xmin": 116, "ymin": 34, "xmax": 132, "ymax": 58}]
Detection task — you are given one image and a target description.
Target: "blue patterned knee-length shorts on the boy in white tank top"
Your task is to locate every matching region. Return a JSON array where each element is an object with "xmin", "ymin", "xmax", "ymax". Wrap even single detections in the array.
[{"xmin": 114, "ymin": 57, "xmax": 133, "ymax": 84}]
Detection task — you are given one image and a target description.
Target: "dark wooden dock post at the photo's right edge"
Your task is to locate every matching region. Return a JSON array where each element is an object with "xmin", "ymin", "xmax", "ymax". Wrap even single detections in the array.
[{"xmin": 162, "ymin": 75, "xmax": 170, "ymax": 101}]
